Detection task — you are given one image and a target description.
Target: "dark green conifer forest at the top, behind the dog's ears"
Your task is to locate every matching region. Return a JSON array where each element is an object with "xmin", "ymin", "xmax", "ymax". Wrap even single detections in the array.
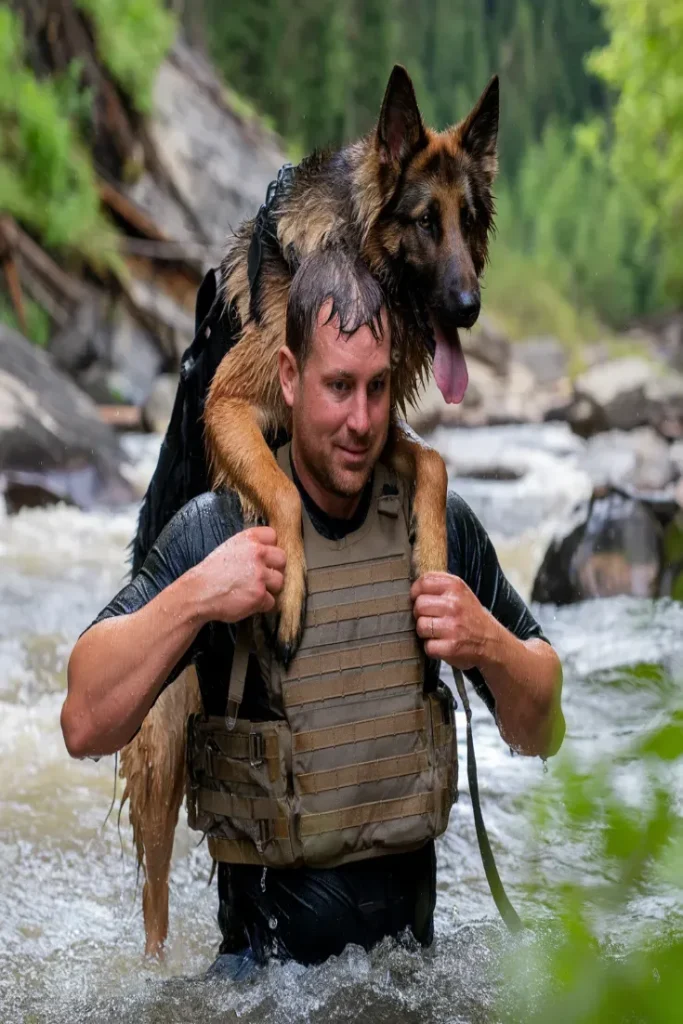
[{"xmin": 206, "ymin": 0, "xmax": 604, "ymax": 172}]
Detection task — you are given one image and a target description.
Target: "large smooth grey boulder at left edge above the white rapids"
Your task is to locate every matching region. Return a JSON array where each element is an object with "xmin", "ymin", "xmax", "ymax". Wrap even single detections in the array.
[{"xmin": 0, "ymin": 324, "xmax": 134, "ymax": 509}]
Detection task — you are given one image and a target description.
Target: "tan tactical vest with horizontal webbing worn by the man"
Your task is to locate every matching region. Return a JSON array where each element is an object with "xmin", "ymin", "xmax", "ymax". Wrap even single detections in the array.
[{"xmin": 187, "ymin": 445, "xmax": 458, "ymax": 867}]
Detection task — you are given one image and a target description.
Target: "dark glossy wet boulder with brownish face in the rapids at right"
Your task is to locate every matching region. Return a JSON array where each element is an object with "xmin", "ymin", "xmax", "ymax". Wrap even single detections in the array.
[{"xmin": 531, "ymin": 490, "xmax": 663, "ymax": 604}]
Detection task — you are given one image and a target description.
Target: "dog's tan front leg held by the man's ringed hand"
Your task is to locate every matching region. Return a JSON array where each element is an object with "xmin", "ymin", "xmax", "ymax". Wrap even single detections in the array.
[{"xmin": 386, "ymin": 423, "xmax": 449, "ymax": 578}]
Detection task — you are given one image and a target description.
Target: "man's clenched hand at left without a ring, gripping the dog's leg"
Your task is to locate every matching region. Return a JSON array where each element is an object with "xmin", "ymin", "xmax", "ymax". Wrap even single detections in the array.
[{"xmin": 188, "ymin": 526, "xmax": 287, "ymax": 623}]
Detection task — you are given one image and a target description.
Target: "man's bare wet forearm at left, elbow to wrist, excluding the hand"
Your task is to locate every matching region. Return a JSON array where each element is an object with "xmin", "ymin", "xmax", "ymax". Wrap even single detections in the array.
[{"xmin": 61, "ymin": 570, "xmax": 203, "ymax": 757}]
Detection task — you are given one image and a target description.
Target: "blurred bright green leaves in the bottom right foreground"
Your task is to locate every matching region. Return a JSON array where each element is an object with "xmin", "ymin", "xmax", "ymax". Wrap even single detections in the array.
[{"xmin": 505, "ymin": 688, "xmax": 683, "ymax": 1024}]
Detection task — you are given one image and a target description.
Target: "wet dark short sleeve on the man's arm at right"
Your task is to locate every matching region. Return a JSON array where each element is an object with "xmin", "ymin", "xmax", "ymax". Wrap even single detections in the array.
[{"xmin": 446, "ymin": 492, "xmax": 548, "ymax": 713}]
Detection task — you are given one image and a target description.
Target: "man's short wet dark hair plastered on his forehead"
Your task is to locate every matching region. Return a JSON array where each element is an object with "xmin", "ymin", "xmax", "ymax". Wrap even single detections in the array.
[{"xmin": 287, "ymin": 247, "xmax": 386, "ymax": 369}]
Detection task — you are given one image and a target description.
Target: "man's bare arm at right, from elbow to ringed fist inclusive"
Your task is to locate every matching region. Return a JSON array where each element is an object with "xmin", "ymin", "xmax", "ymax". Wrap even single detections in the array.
[{"xmin": 411, "ymin": 572, "xmax": 564, "ymax": 757}]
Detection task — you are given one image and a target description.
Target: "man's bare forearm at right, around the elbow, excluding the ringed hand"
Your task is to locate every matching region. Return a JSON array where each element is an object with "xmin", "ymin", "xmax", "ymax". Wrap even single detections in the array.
[{"xmin": 478, "ymin": 624, "xmax": 564, "ymax": 757}]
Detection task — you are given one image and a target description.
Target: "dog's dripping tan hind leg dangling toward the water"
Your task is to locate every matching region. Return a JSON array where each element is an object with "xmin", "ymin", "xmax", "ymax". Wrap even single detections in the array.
[{"xmin": 121, "ymin": 669, "xmax": 201, "ymax": 956}]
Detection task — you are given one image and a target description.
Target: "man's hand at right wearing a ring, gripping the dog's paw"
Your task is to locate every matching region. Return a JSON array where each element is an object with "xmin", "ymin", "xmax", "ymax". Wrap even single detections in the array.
[{"xmin": 411, "ymin": 572, "xmax": 503, "ymax": 672}]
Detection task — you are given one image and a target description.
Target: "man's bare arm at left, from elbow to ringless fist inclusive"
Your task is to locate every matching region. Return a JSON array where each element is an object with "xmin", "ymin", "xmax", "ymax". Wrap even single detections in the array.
[{"xmin": 61, "ymin": 526, "xmax": 285, "ymax": 757}]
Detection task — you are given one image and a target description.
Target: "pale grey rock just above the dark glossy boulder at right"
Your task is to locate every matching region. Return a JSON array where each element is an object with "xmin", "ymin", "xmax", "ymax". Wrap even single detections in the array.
[{"xmin": 581, "ymin": 427, "xmax": 676, "ymax": 490}]
